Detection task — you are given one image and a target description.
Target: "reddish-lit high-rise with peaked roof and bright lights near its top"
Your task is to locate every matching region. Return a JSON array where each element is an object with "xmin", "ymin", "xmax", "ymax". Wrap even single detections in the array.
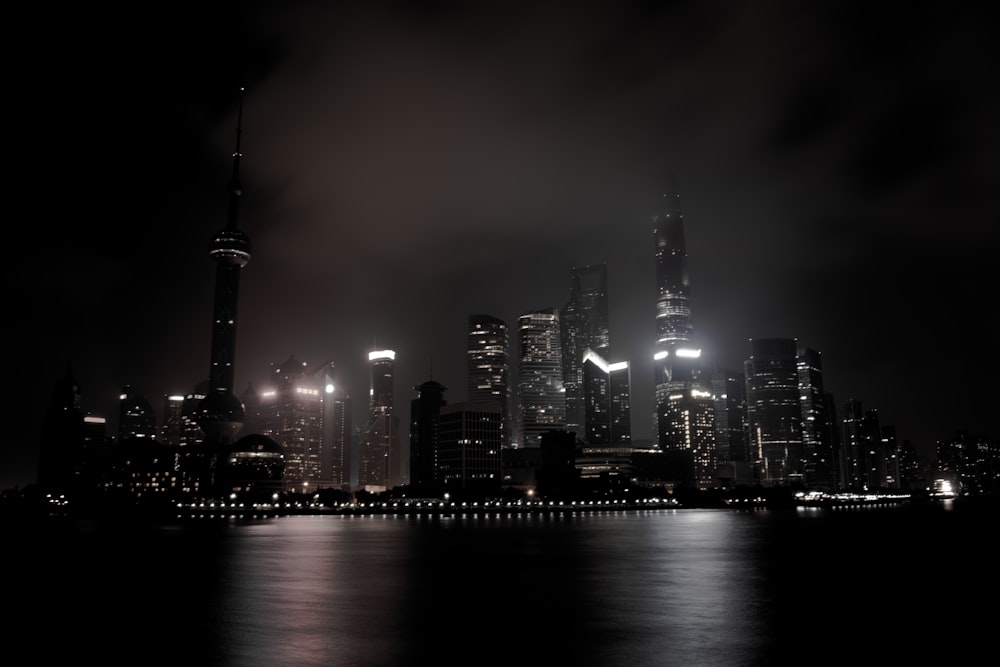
[{"xmin": 260, "ymin": 355, "xmax": 327, "ymax": 493}]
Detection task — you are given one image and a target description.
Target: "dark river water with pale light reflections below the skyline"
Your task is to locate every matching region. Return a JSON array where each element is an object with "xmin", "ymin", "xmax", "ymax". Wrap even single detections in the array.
[{"xmin": 0, "ymin": 503, "xmax": 1000, "ymax": 667}]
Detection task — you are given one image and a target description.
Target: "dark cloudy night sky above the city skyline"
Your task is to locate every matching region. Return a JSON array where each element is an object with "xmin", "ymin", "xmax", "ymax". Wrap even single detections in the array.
[{"xmin": 0, "ymin": 1, "xmax": 1000, "ymax": 488}]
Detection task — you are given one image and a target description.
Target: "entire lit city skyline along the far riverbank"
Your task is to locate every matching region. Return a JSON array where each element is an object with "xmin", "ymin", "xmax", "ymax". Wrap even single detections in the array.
[{"xmin": 27, "ymin": 111, "xmax": 1000, "ymax": 506}]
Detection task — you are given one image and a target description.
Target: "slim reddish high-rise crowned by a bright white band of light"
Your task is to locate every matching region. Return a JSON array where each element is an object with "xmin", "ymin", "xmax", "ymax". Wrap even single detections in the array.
[{"xmin": 358, "ymin": 350, "xmax": 403, "ymax": 492}]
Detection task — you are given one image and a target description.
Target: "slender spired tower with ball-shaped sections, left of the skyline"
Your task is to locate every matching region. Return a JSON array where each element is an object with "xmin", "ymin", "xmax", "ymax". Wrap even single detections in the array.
[{"xmin": 198, "ymin": 88, "xmax": 250, "ymax": 456}]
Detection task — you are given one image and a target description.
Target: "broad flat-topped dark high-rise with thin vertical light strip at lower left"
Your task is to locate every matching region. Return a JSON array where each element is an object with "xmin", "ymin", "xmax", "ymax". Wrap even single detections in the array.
[{"xmin": 744, "ymin": 338, "xmax": 805, "ymax": 486}]
